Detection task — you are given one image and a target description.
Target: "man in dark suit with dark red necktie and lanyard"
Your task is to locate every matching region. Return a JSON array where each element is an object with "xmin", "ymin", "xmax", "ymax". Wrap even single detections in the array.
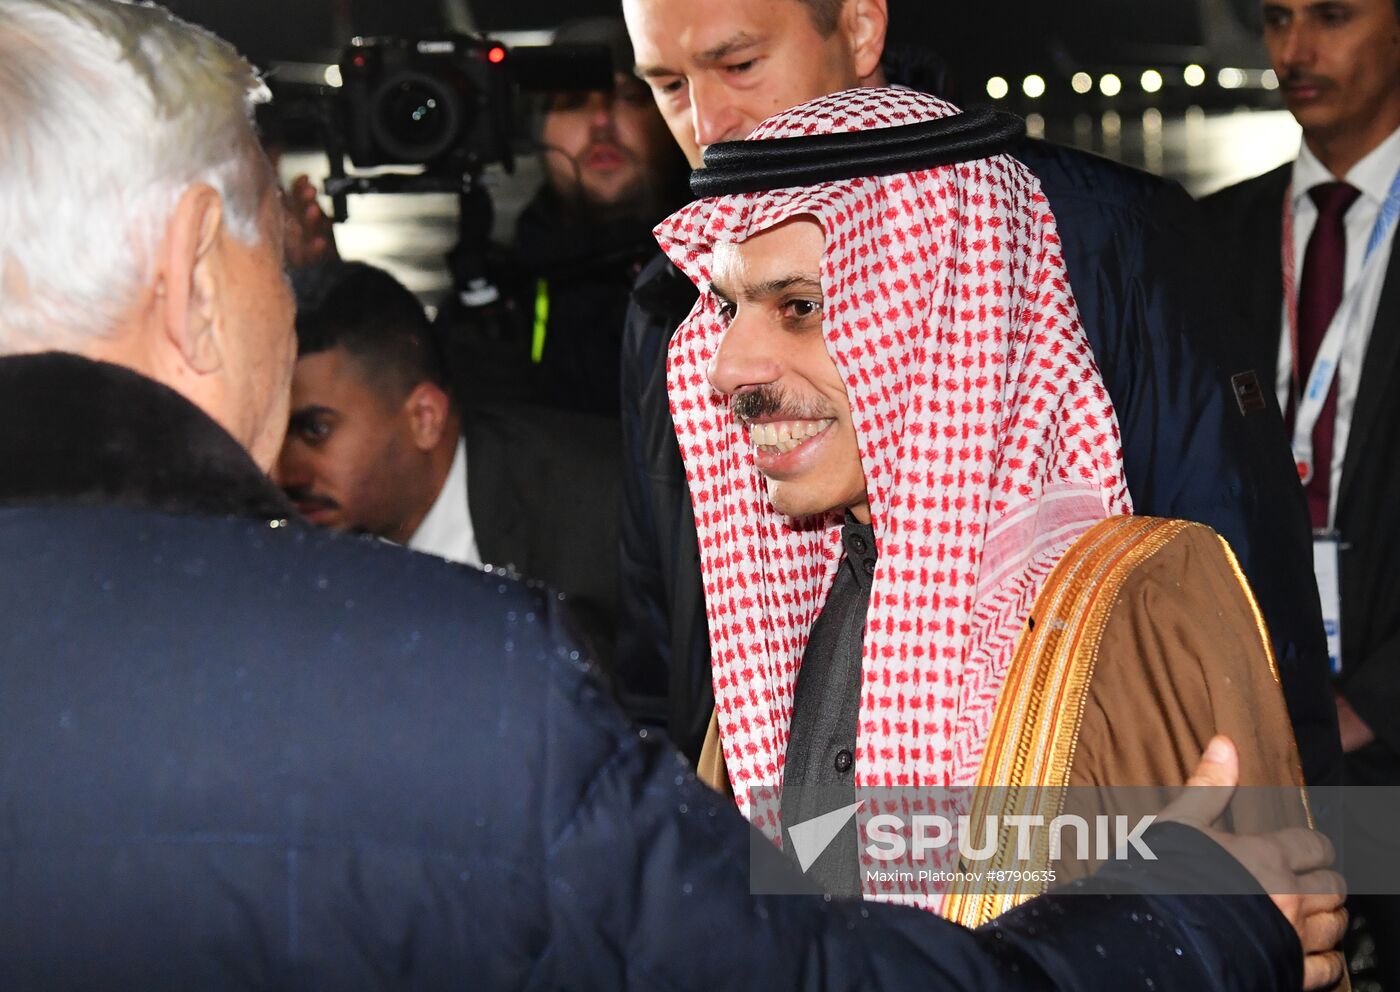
[{"xmin": 1204, "ymin": 0, "xmax": 1400, "ymax": 973}]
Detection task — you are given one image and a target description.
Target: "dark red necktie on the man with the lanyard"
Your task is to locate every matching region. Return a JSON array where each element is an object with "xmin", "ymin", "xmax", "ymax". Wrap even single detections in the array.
[{"xmin": 1288, "ymin": 182, "xmax": 1361, "ymax": 530}]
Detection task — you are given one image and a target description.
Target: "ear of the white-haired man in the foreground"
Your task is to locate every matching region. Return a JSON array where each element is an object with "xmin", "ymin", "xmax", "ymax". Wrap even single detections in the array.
[{"xmin": 155, "ymin": 183, "xmax": 224, "ymax": 375}]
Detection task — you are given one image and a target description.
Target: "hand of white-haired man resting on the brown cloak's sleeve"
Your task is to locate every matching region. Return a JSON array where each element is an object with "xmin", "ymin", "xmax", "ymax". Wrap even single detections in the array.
[{"xmin": 1161, "ymin": 737, "xmax": 1347, "ymax": 989}]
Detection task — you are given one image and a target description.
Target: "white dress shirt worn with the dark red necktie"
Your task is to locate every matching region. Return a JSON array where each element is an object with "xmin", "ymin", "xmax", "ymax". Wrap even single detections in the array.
[{"xmin": 1275, "ymin": 123, "xmax": 1400, "ymax": 523}]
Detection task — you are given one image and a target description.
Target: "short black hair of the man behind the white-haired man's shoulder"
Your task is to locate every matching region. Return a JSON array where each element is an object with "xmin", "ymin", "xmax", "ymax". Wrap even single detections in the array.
[{"xmin": 297, "ymin": 262, "xmax": 447, "ymax": 402}]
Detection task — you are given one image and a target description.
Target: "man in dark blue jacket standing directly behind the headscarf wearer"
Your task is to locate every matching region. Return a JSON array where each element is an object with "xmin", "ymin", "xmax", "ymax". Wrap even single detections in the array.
[{"xmin": 619, "ymin": 0, "xmax": 1341, "ymax": 784}]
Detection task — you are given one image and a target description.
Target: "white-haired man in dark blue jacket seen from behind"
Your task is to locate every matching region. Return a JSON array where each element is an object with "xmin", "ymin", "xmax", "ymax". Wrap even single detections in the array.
[{"xmin": 0, "ymin": 0, "xmax": 1343, "ymax": 992}]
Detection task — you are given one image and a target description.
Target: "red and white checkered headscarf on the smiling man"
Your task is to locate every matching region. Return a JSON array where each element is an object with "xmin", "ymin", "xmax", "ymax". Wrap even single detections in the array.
[{"xmin": 657, "ymin": 88, "xmax": 1131, "ymax": 834}]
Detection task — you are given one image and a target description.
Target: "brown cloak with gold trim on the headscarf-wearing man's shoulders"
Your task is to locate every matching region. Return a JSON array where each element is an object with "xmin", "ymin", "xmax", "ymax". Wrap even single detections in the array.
[{"xmin": 699, "ymin": 516, "xmax": 1309, "ymax": 926}]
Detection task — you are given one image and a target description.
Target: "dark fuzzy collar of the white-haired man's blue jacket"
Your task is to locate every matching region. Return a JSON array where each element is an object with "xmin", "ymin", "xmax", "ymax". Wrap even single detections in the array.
[{"xmin": 0, "ymin": 353, "xmax": 295, "ymax": 520}]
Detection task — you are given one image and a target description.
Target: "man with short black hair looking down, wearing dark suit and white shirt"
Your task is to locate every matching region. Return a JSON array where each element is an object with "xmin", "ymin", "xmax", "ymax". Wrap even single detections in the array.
[{"xmin": 276, "ymin": 262, "xmax": 619, "ymax": 660}]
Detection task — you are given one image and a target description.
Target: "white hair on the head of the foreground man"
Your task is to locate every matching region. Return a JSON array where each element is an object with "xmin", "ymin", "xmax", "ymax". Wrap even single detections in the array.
[{"xmin": 0, "ymin": 0, "xmax": 272, "ymax": 354}]
